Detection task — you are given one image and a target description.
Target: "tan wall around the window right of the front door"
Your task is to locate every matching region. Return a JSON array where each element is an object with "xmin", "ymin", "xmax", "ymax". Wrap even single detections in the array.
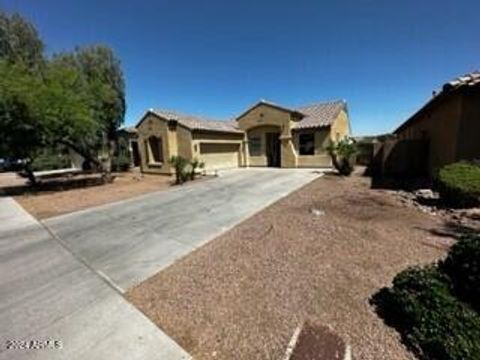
[{"xmin": 293, "ymin": 128, "xmax": 332, "ymax": 167}]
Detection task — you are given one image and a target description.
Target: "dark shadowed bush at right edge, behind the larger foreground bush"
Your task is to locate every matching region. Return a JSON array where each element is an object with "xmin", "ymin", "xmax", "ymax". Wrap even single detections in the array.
[{"xmin": 440, "ymin": 235, "xmax": 480, "ymax": 310}]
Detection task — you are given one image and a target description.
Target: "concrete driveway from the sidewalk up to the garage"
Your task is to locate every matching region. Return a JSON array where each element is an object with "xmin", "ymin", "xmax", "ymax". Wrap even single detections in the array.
[{"xmin": 45, "ymin": 169, "xmax": 320, "ymax": 291}]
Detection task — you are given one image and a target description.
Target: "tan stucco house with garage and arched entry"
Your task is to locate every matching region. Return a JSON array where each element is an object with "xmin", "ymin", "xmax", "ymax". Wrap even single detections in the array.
[{"xmin": 136, "ymin": 100, "xmax": 350, "ymax": 174}]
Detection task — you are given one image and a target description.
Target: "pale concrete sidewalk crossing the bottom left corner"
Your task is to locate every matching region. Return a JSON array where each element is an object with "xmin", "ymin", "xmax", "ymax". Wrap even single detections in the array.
[{"xmin": 0, "ymin": 198, "xmax": 190, "ymax": 360}]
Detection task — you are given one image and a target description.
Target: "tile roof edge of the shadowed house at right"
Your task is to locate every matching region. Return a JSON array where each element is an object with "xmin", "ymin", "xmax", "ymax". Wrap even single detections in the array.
[{"xmin": 393, "ymin": 70, "xmax": 480, "ymax": 134}]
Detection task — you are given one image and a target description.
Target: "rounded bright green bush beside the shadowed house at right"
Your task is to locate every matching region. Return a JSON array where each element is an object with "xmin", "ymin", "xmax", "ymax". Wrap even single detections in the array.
[{"xmin": 436, "ymin": 162, "xmax": 480, "ymax": 207}]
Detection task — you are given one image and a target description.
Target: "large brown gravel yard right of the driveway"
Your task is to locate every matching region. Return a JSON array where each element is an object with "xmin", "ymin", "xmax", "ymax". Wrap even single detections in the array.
[{"xmin": 127, "ymin": 176, "xmax": 452, "ymax": 360}]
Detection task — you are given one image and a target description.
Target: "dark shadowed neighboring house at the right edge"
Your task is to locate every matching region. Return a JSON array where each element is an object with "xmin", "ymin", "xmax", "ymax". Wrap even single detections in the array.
[{"xmin": 384, "ymin": 71, "xmax": 480, "ymax": 175}]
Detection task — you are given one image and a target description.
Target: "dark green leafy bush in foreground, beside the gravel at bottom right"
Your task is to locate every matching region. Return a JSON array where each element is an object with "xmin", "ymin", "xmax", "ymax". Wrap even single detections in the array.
[{"xmin": 373, "ymin": 266, "xmax": 480, "ymax": 360}]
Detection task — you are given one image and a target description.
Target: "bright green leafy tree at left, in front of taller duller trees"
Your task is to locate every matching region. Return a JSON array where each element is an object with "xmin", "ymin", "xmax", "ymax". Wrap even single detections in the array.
[{"xmin": 0, "ymin": 60, "xmax": 98, "ymax": 184}]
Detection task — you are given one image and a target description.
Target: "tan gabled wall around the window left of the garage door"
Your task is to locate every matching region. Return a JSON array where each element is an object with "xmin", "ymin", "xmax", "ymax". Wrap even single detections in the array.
[{"xmin": 137, "ymin": 114, "xmax": 176, "ymax": 174}]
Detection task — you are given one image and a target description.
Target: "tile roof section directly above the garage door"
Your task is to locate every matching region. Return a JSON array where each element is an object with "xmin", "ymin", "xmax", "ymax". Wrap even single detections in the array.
[{"xmin": 152, "ymin": 109, "xmax": 242, "ymax": 133}]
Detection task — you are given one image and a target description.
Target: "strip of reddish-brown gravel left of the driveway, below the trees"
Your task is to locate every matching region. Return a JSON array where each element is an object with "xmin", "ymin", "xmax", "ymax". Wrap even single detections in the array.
[{"xmin": 14, "ymin": 171, "xmax": 173, "ymax": 219}]
